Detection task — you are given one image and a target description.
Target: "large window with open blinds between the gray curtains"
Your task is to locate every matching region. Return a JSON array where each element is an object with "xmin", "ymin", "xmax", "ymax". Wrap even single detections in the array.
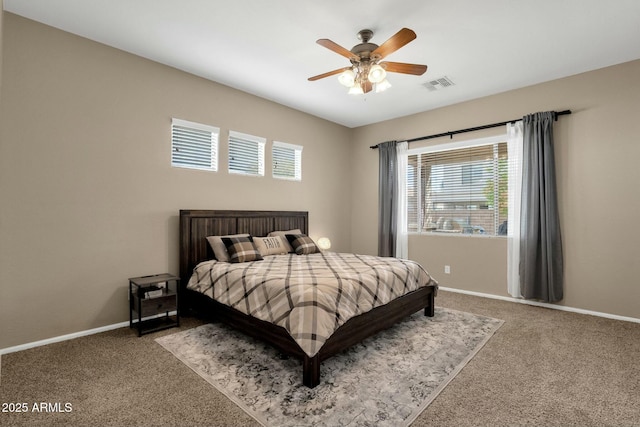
[{"xmin": 407, "ymin": 138, "xmax": 508, "ymax": 235}]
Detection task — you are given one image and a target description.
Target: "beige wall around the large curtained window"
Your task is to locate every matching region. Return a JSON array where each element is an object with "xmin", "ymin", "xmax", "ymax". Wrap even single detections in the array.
[{"xmin": 351, "ymin": 61, "xmax": 640, "ymax": 318}]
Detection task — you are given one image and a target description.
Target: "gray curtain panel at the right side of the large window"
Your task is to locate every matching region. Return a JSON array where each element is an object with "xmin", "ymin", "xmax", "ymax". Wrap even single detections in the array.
[{"xmin": 520, "ymin": 112, "xmax": 563, "ymax": 302}]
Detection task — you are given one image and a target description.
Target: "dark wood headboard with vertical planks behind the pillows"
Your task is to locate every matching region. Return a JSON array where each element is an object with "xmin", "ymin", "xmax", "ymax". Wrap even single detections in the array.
[{"xmin": 180, "ymin": 210, "xmax": 309, "ymax": 286}]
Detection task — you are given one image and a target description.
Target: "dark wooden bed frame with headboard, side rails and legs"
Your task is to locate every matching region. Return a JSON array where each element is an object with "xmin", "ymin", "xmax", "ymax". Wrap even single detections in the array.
[{"xmin": 178, "ymin": 210, "xmax": 435, "ymax": 388}]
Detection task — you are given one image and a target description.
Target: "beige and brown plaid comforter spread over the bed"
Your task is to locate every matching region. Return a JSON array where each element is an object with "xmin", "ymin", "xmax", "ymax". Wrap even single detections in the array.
[{"xmin": 187, "ymin": 252, "xmax": 438, "ymax": 357}]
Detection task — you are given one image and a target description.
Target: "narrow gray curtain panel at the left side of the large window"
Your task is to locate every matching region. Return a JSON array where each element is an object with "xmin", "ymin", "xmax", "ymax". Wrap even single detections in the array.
[{"xmin": 378, "ymin": 141, "xmax": 398, "ymax": 256}]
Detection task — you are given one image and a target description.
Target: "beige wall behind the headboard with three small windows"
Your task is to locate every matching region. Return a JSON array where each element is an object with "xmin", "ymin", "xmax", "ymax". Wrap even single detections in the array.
[{"xmin": 0, "ymin": 13, "xmax": 351, "ymax": 348}]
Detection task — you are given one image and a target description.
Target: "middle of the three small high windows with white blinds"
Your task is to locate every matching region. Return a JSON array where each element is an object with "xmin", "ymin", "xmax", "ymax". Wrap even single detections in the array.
[{"xmin": 229, "ymin": 131, "xmax": 266, "ymax": 176}]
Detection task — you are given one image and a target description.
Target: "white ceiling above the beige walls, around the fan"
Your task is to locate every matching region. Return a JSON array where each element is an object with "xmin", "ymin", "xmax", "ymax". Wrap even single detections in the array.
[{"xmin": 4, "ymin": 0, "xmax": 640, "ymax": 127}]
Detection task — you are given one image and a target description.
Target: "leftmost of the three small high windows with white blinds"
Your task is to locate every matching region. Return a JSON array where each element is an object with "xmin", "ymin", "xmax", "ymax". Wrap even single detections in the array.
[{"xmin": 171, "ymin": 119, "xmax": 220, "ymax": 171}]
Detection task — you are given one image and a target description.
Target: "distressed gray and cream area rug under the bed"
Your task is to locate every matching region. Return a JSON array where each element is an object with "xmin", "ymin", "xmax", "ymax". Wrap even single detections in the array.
[{"xmin": 156, "ymin": 308, "xmax": 503, "ymax": 427}]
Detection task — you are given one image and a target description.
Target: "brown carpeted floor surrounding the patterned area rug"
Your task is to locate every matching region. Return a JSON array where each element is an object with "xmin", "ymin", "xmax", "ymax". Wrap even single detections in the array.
[{"xmin": 0, "ymin": 291, "xmax": 640, "ymax": 426}]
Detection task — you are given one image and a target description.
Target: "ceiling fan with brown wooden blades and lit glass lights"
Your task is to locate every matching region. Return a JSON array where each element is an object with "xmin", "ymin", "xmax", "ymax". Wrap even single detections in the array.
[{"xmin": 308, "ymin": 28, "xmax": 427, "ymax": 94}]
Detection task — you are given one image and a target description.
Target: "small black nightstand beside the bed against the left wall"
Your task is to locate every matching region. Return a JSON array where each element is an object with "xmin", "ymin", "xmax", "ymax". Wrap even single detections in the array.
[{"xmin": 129, "ymin": 273, "xmax": 180, "ymax": 336}]
